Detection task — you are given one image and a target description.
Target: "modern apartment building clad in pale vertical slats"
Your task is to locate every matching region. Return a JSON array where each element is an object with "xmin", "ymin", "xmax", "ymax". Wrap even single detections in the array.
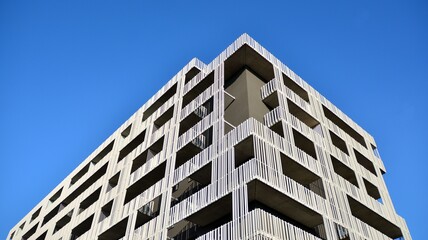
[{"xmin": 8, "ymin": 34, "xmax": 411, "ymax": 240}]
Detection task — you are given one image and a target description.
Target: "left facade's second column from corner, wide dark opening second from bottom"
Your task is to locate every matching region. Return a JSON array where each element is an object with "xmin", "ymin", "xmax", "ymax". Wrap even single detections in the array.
[{"xmin": 124, "ymin": 161, "xmax": 166, "ymax": 204}]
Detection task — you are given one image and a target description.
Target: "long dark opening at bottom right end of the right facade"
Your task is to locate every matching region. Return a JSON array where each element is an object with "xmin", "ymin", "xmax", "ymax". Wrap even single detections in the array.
[{"xmin": 347, "ymin": 195, "xmax": 403, "ymax": 239}]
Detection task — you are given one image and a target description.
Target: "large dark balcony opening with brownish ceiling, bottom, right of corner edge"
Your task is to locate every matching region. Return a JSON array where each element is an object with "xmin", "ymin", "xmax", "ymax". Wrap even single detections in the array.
[{"xmin": 248, "ymin": 180, "xmax": 325, "ymax": 239}]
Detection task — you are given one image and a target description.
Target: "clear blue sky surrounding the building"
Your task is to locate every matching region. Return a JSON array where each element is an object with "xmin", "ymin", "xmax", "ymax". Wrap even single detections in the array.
[{"xmin": 0, "ymin": 0, "xmax": 428, "ymax": 239}]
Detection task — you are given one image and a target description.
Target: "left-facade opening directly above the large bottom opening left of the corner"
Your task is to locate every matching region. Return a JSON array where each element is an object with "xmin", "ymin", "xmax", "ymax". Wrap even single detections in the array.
[{"xmin": 171, "ymin": 162, "xmax": 212, "ymax": 206}]
